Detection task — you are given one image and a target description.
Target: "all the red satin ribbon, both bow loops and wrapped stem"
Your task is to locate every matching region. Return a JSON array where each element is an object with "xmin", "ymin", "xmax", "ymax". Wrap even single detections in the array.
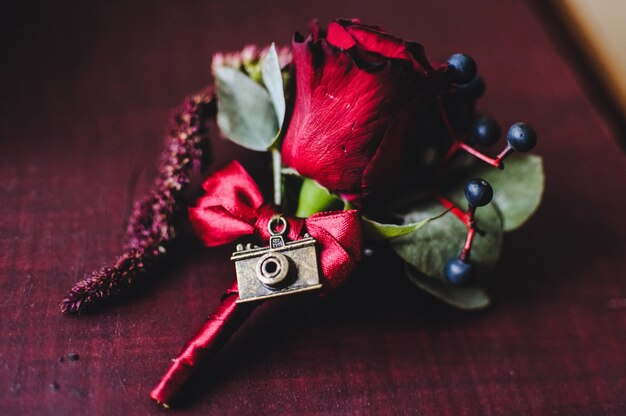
[{"xmin": 150, "ymin": 162, "xmax": 361, "ymax": 406}]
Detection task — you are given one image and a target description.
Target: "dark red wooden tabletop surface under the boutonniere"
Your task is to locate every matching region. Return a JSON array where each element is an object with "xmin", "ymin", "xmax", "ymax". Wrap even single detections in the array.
[{"xmin": 0, "ymin": 0, "xmax": 626, "ymax": 415}]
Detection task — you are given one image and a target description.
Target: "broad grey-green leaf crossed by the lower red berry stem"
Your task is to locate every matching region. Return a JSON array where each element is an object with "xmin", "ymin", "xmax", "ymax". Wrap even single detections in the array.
[{"xmin": 390, "ymin": 193, "xmax": 502, "ymax": 290}]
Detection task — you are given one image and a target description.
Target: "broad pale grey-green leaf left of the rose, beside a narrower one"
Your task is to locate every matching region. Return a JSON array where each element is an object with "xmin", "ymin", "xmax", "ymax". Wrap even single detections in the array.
[{"xmin": 215, "ymin": 67, "xmax": 279, "ymax": 151}]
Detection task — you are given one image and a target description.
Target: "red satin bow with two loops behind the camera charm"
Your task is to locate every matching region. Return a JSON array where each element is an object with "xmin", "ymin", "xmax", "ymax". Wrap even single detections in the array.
[{"xmin": 189, "ymin": 161, "xmax": 362, "ymax": 288}]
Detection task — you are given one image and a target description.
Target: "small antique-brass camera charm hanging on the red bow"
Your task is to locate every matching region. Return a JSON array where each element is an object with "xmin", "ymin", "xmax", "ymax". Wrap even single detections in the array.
[{"xmin": 230, "ymin": 216, "xmax": 322, "ymax": 302}]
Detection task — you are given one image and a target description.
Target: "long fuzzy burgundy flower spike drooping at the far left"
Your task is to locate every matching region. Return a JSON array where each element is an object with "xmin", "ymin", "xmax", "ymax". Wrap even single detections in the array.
[{"xmin": 61, "ymin": 88, "xmax": 216, "ymax": 313}]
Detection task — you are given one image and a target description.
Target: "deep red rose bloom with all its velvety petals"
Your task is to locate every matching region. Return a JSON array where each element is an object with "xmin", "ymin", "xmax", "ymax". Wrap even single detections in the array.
[{"xmin": 282, "ymin": 20, "xmax": 441, "ymax": 197}]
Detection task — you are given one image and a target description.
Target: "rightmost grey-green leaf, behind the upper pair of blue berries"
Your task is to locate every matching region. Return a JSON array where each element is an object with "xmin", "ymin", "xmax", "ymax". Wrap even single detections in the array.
[{"xmin": 468, "ymin": 154, "xmax": 545, "ymax": 232}]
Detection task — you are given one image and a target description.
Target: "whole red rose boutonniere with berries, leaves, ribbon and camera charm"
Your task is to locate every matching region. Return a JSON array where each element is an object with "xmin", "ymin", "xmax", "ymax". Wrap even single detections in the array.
[{"xmin": 62, "ymin": 19, "xmax": 544, "ymax": 405}]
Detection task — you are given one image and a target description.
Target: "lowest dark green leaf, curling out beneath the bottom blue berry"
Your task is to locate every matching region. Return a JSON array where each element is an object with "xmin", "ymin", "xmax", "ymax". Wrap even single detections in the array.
[{"xmin": 405, "ymin": 264, "xmax": 491, "ymax": 310}]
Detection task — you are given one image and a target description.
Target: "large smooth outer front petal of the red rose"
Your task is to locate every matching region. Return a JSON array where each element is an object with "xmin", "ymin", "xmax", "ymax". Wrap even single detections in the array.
[{"xmin": 283, "ymin": 38, "xmax": 418, "ymax": 193}]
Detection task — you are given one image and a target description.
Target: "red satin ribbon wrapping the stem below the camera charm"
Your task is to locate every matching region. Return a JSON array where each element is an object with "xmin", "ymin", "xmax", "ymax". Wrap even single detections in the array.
[{"xmin": 150, "ymin": 282, "xmax": 259, "ymax": 407}]
